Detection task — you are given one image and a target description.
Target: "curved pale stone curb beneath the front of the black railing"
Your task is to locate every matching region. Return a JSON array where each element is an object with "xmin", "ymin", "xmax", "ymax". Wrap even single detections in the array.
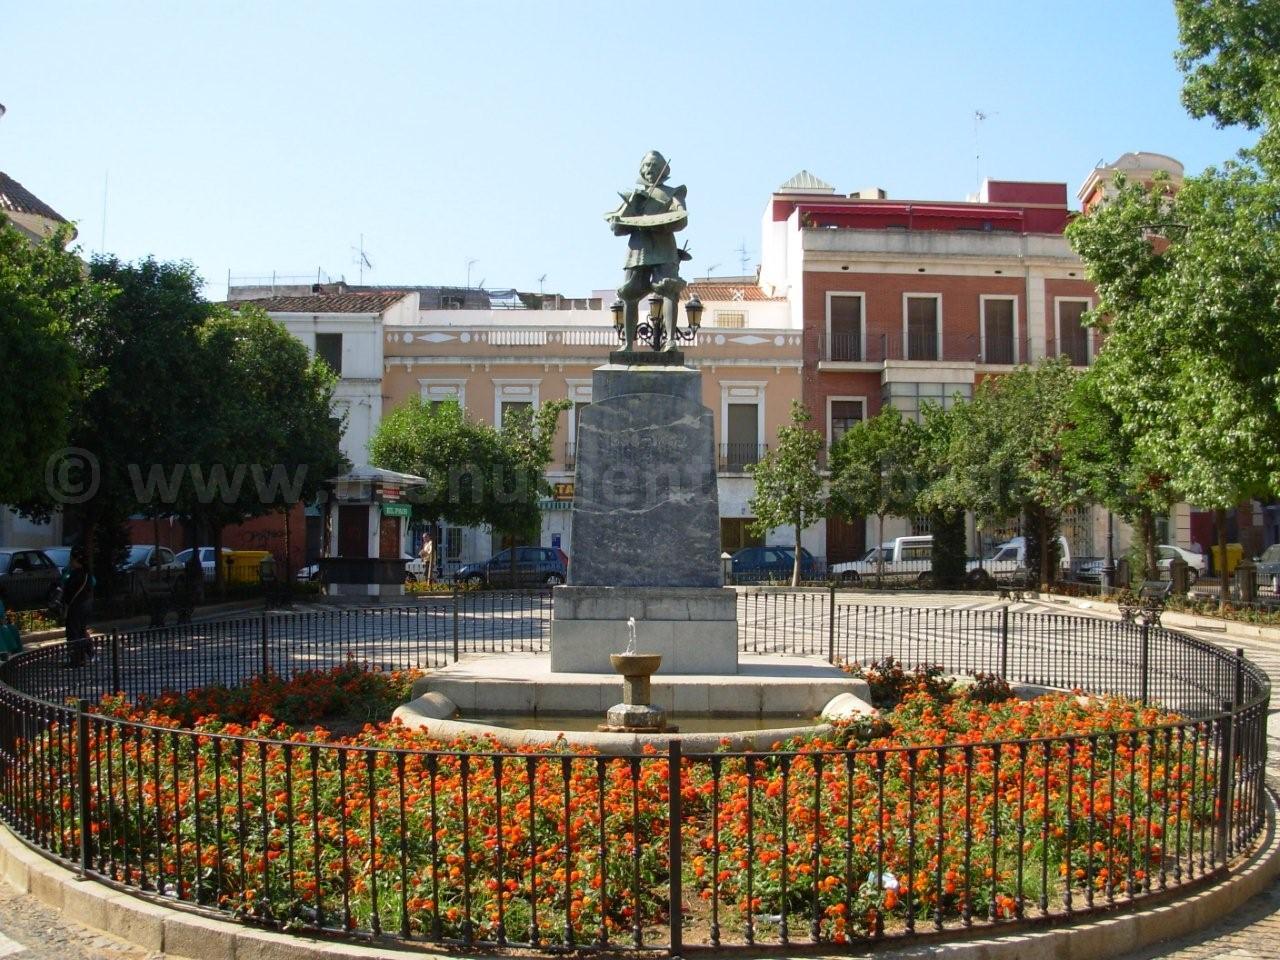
[{"xmin": 0, "ymin": 791, "xmax": 1280, "ymax": 960}]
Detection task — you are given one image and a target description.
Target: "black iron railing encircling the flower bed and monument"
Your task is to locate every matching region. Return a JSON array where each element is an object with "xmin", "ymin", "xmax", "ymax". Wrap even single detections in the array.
[{"xmin": 0, "ymin": 590, "xmax": 1270, "ymax": 954}]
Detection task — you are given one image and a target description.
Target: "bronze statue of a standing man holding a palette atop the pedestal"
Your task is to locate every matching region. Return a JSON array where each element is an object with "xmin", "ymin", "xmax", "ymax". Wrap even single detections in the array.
[{"xmin": 604, "ymin": 150, "xmax": 689, "ymax": 351}]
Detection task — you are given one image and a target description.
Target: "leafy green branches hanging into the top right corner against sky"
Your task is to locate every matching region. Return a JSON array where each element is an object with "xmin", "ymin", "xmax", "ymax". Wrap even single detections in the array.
[{"xmin": 1174, "ymin": 0, "xmax": 1280, "ymax": 172}]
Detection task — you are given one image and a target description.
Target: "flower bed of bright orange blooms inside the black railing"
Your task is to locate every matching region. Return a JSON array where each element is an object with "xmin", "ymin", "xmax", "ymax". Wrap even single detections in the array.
[{"xmin": 7, "ymin": 664, "xmax": 1216, "ymax": 946}]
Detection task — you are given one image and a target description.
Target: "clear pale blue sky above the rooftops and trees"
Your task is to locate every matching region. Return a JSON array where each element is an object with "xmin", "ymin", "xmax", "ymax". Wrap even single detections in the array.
[{"xmin": 0, "ymin": 0, "xmax": 1253, "ymax": 298}]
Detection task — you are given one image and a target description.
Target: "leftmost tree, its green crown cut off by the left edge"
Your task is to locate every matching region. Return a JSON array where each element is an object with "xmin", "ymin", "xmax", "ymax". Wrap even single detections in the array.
[{"xmin": 0, "ymin": 214, "xmax": 94, "ymax": 503}]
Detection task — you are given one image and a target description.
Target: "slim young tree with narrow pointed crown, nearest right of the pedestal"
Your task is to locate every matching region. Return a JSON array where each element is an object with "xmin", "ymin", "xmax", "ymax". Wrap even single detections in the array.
[{"xmin": 749, "ymin": 401, "xmax": 827, "ymax": 586}]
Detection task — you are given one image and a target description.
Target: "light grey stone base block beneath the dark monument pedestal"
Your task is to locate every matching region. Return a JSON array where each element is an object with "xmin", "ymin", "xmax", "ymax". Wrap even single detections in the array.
[{"xmin": 550, "ymin": 586, "xmax": 737, "ymax": 676}]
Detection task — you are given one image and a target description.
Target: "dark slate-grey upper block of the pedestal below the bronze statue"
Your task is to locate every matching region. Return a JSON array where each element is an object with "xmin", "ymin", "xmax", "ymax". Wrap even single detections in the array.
[{"xmin": 570, "ymin": 371, "xmax": 722, "ymax": 588}]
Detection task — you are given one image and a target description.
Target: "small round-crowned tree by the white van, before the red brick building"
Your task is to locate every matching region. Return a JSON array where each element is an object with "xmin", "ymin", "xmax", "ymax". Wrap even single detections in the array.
[{"xmin": 831, "ymin": 407, "xmax": 922, "ymax": 577}]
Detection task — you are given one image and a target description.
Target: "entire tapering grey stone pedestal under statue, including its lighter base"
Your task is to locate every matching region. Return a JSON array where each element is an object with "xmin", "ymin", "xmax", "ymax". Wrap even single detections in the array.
[{"xmin": 550, "ymin": 364, "xmax": 737, "ymax": 675}]
